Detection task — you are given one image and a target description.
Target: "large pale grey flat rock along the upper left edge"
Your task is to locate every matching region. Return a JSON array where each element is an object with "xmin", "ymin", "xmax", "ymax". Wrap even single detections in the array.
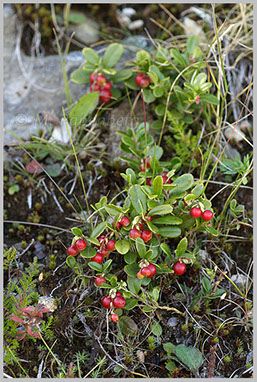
[{"xmin": 4, "ymin": 5, "xmax": 85, "ymax": 144}]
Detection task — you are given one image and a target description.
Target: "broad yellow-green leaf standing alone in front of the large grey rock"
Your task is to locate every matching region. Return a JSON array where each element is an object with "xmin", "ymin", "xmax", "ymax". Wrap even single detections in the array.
[{"xmin": 70, "ymin": 92, "xmax": 99, "ymax": 127}]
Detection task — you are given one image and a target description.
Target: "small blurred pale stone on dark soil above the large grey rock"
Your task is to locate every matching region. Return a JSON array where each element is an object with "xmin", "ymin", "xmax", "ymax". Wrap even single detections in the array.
[{"xmin": 69, "ymin": 14, "xmax": 99, "ymax": 45}]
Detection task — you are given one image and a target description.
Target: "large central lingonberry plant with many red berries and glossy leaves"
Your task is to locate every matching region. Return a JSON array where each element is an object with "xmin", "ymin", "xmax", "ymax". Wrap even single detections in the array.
[{"xmin": 67, "ymin": 145, "xmax": 218, "ymax": 322}]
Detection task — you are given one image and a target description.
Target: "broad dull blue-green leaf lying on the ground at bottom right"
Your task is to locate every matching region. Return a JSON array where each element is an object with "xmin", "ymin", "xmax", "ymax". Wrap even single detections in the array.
[{"xmin": 175, "ymin": 344, "xmax": 204, "ymax": 373}]
